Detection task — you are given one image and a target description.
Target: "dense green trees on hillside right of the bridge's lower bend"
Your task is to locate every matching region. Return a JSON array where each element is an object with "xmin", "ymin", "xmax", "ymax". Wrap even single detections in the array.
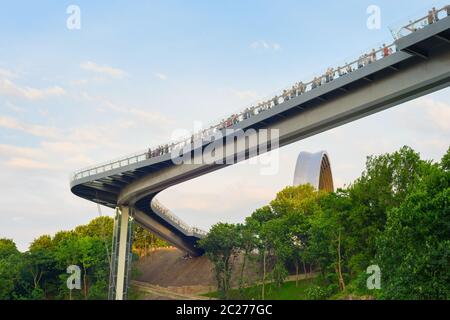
[{"xmin": 200, "ymin": 147, "xmax": 450, "ymax": 299}]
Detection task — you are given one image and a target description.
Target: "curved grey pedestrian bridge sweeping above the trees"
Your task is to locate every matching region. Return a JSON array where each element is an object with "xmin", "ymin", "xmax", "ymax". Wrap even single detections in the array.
[{"xmin": 70, "ymin": 17, "xmax": 450, "ymax": 255}]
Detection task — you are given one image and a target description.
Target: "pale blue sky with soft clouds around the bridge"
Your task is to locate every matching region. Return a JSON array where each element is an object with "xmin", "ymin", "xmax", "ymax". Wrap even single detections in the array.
[{"xmin": 0, "ymin": 0, "xmax": 450, "ymax": 250}]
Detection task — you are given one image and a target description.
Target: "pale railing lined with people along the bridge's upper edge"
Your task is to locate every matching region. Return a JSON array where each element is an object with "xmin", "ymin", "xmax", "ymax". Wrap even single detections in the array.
[{"xmin": 71, "ymin": 5, "xmax": 450, "ymax": 182}]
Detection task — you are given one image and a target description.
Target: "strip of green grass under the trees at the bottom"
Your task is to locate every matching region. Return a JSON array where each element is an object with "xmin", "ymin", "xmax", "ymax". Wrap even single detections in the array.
[{"xmin": 200, "ymin": 279, "xmax": 318, "ymax": 300}]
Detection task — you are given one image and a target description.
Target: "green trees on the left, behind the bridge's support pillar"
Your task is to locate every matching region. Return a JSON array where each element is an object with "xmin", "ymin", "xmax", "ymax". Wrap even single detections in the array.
[{"xmin": 0, "ymin": 216, "xmax": 167, "ymax": 300}]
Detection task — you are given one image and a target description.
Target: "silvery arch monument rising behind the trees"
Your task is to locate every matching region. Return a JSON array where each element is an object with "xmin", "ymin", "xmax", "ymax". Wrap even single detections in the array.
[{"xmin": 294, "ymin": 151, "xmax": 334, "ymax": 192}]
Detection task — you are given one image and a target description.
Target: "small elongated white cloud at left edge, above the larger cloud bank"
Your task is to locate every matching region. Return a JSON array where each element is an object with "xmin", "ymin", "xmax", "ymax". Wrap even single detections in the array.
[{"xmin": 0, "ymin": 79, "xmax": 66, "ymax": 101}]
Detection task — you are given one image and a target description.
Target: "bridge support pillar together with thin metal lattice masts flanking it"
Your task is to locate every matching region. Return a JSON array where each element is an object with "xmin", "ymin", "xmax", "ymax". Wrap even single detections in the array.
[{"xmin": 108, "ymin": 207, "xmax": 133, "ymax": 300}]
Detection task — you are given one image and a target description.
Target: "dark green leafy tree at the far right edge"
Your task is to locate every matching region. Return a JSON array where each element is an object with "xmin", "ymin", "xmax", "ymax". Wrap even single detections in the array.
[{"xmin": 377, "ymin": 156, "xmax": 450, "ymax": 299}]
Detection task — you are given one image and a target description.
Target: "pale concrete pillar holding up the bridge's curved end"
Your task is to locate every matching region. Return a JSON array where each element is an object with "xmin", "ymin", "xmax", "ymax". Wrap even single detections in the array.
[{"xmin": 116, "ymin": 207, "xmax": 130, "ymax": 300}]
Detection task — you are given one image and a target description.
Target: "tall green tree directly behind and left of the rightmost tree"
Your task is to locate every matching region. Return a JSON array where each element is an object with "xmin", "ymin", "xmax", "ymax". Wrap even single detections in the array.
[{"xmin": 347, "ymin": 147, "xmax": 425, "ymax": 274}]
